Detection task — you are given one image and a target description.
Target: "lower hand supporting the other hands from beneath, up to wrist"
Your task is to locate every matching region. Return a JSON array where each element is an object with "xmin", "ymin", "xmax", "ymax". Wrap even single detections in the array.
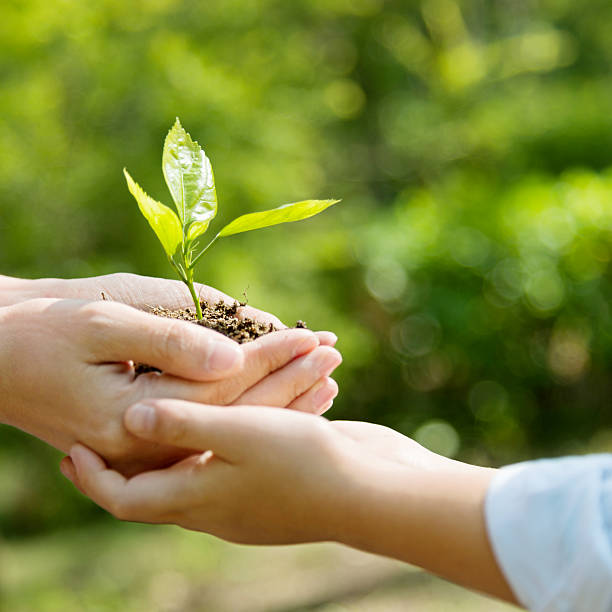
[{"xmin": 62, "ymin": 400, "xmax": 448, "ymax": 544}]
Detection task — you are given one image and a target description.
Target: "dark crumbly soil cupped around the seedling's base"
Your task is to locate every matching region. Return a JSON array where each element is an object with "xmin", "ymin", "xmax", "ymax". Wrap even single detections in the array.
[{"xmin": 134, "ymin": 301, "xmax": 306, "ymax": 374}]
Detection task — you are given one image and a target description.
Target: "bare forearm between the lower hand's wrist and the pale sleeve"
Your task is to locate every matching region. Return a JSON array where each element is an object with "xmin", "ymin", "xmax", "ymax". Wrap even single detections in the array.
[{"xmin": 338, "ymin": 462, "xmax": 516, "ymax": 603}]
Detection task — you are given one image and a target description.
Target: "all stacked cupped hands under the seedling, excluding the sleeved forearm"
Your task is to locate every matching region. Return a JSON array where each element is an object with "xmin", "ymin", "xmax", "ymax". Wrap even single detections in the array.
[{"xmin": 0, "ymin": 274, "xmax": 445, "ymax": 543}]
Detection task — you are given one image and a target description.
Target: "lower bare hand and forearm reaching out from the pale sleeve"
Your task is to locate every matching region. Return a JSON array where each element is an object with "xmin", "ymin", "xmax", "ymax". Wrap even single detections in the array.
[{"xmin": 61, "ymin": 400, "xmax": 516, "ymax": 603}]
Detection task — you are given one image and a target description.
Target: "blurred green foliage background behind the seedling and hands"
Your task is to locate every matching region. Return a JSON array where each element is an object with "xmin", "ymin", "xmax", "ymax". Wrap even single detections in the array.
[{"xmin": 0, "ymin": 0, "xmax": 612, "ymax": 535}]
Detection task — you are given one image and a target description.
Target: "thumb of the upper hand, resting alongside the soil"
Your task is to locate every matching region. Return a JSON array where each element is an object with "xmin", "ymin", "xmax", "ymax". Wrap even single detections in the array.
[{"xmin": 86, "ymin": 302, "xmax": 243, "ymax": 381}]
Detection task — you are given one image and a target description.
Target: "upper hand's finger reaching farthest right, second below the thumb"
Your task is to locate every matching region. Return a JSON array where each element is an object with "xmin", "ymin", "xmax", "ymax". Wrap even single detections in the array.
[{"xmin": 233, "ymin": 346, "xmax": 342, "ymax": 412}]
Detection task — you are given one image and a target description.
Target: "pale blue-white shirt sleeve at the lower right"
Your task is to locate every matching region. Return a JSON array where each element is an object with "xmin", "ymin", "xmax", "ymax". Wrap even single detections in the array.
[{"xmin": 485, "ymin": 454, "xmax": 612, "ymax": 612}]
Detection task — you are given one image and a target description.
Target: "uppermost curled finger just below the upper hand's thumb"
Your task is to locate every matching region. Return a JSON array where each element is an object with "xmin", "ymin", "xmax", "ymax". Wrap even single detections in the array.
[{"xmin": 137, "ymin": 329, "xmax": 320, "ymax": 406}]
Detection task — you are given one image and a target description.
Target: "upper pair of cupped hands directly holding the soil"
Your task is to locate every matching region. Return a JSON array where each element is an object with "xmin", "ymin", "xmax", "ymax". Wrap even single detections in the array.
[{"xmin": 0, "ymin": 275, "xmax": 342, "ymax": 474}]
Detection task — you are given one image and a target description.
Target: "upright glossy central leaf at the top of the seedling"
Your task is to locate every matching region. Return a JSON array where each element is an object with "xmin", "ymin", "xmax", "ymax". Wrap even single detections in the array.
[{"xmin": 162, "ymin": 117, "xmax": 217, "ymax": 240}]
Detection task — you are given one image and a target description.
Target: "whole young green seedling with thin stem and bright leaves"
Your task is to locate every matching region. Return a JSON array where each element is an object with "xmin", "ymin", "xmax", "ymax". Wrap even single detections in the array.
[{"xmin": 123, "ymin": 118, "xmax": 340, "ymax": 319}]
